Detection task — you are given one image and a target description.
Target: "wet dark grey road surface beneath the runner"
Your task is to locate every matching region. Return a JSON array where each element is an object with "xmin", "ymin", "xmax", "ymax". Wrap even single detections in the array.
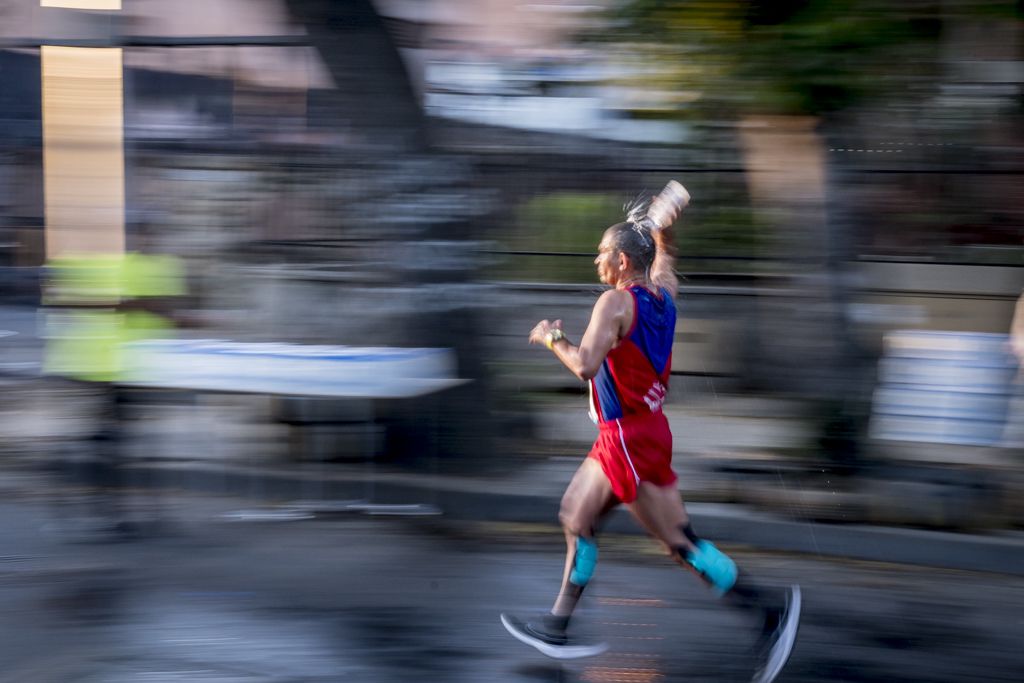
[{"xmin": 0, "ymin": 496, "xmax": 1024, "ymax": 683}]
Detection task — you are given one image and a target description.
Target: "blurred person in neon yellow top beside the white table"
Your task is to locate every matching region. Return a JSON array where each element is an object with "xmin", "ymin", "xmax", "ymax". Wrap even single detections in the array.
[{"xmin": 43, "ymin": 248, "xmax": 185, "ymax": 535}]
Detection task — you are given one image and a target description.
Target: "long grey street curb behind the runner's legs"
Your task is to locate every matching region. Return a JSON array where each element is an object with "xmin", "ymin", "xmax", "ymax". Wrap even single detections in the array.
[{"xmin": 83, "ymin": 464, "xmax": 1024, "ymax": 575}]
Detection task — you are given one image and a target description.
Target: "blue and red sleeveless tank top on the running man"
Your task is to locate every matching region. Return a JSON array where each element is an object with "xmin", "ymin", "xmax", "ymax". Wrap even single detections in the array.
[{"xmin": 590, "ymin": 286, "xmax": 676, "ymax": 423}]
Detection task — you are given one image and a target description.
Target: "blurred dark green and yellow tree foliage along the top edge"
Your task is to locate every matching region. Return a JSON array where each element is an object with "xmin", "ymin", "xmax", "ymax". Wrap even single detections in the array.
[{"xmin": 597, "ymin": 0, "xmax": 946, "ymax": 117}]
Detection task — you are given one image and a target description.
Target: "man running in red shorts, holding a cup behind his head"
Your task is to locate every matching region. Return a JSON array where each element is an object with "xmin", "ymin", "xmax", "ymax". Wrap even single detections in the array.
[{"xmin": 502, "ymin": 181, "xmax": 800, "ymax": 683}]
